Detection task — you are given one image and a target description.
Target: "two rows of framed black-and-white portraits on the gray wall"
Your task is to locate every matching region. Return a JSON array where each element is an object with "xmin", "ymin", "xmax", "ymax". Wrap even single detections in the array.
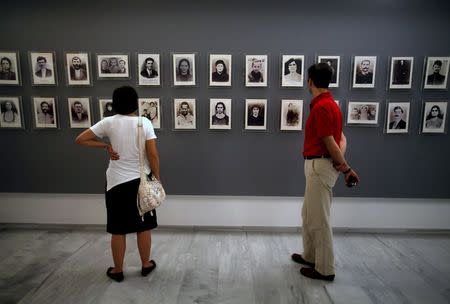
[{"xmin": 0, "ymin": 51, "xmax": 450, "ymax": 134}]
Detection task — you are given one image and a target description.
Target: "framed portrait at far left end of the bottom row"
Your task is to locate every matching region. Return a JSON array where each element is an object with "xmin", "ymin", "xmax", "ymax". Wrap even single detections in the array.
[{"xmin": 0, "ymin": 96, "xmax": 24, "ymax": 128}]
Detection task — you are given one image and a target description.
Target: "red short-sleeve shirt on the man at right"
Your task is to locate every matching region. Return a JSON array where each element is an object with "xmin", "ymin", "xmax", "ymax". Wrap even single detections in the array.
[{"xmin": 303, "ymin": 92, "xmax": 342, "ymax": 156}]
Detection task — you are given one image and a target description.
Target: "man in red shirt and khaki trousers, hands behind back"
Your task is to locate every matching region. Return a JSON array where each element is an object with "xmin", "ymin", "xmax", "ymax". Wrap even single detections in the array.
[{"xmin": 292, "ymin": 63, "xmax": 359, "ymax": 281}]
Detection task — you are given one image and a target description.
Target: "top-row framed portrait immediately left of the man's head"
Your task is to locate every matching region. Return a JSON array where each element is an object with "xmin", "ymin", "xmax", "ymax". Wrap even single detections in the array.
[{"xmin": 281, "ymin": 55, "xmax": 305, "ymax": 87}]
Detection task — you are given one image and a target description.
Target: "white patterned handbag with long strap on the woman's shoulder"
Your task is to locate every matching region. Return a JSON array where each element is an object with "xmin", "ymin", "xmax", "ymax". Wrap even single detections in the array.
[{"xmin": 137, "ymin": 117, "xmax": 166, "ymax": 220}]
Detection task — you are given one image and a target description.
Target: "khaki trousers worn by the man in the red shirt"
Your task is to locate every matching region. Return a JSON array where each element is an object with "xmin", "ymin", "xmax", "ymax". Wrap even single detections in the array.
[{"xmin": 302, "ymin": 158, "xmax": 339, "ymax": 275}]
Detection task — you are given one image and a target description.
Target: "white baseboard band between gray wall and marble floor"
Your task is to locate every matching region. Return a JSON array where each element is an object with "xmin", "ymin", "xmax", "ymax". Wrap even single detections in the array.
[{"xmin": 0, "ymin": 193, "xmax": 450, "ymax": 230}]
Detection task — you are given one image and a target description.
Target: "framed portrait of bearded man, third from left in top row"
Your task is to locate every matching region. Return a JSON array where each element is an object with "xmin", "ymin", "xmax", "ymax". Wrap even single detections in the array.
[{"xmin": 65, "ymin": 52, "xmax": 92, "ymax": 86}]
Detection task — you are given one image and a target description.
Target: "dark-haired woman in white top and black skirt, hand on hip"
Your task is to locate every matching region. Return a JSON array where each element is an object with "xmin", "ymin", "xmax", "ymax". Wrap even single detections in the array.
[{"xmin": 76, "ymin": 86, "xmax": 160, "ymax": 282}]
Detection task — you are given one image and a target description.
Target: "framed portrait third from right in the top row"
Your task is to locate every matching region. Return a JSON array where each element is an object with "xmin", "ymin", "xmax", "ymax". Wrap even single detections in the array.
[{"xmin": 352, "ymin": 56, "xmax": 377, "ymax": 88}]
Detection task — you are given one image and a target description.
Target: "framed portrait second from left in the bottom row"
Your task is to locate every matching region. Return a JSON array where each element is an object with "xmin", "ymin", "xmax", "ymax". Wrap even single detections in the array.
[{"xmin": 32, "ymin": 97, "xmax": 57, "ymax": 128}]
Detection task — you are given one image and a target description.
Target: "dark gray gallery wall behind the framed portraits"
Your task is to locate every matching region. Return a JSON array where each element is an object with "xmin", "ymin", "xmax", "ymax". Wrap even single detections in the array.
[{"xmin": 0, "ymin": 0, "xmax": 450, "ymax": 198}]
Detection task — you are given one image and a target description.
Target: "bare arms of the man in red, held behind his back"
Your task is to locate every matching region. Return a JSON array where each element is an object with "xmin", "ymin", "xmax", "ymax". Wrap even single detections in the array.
[{"xmin": 322, "ymin": 133, "xmax": 359, "ymax": 183}]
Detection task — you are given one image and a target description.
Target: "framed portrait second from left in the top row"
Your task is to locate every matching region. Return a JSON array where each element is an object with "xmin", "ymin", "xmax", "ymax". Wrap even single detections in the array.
[{"xmin": 30, "ymin": 52, "xmax": 57, "ymax": 85}]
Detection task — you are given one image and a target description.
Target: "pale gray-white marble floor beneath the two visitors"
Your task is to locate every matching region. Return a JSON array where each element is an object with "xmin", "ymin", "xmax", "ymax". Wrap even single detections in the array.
[{"xmin": 0, "ymin": 226, "xmax": 450, "ymax": 304}]
